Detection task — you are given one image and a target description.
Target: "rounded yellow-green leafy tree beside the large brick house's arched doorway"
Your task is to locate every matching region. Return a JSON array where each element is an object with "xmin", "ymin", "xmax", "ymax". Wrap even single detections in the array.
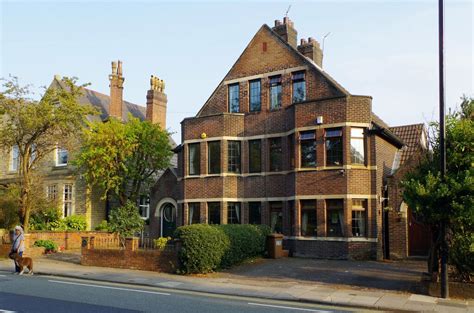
[{"xmin": 75, "ymin": 115, "xmax": 173, "ymax": 206}]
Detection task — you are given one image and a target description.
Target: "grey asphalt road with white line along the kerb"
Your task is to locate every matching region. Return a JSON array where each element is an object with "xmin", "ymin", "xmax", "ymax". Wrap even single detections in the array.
[{"xmin": 0, "ymin": 272, "xmax": 378, "ymax": 313}]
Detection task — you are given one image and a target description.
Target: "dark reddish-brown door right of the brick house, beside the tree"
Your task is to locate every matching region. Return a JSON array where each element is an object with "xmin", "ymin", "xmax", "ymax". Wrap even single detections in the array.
[{"xmin": 408, "ymin": 208, "xmax": 431, "ymax": 256}]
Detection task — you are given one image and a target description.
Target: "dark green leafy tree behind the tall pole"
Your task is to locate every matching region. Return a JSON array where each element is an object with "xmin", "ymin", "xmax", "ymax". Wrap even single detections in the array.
[{"xmin": 402, "ymin": 97, "xmax": 474, "ymax": 280}]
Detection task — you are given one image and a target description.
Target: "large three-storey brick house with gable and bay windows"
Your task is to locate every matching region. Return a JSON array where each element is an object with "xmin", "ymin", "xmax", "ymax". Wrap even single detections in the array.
[{"xmin": 150, "ymin": 17, "xmax": 424, "ymax": 258}]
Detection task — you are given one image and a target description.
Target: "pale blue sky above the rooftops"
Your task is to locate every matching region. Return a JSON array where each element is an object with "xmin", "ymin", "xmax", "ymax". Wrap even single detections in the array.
[{"xmin": 0, "ymin": 0, "xmax": 474, "ymax": 143}]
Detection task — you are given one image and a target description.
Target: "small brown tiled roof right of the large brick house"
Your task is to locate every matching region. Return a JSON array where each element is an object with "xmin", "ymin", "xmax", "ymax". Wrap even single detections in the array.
[{"xmin": 390, "ymin": 124, "xmax": 428, "ymax": 165}]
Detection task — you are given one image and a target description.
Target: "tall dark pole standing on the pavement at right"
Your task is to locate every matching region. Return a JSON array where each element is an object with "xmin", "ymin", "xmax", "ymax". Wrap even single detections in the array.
[{"xmin": 438, "ymin": 0, "xmax": 449, "ymax": 298}]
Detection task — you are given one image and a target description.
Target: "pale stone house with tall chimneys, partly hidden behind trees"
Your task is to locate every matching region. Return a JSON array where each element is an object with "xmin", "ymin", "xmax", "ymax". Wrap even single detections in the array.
[{"xmin": 0, "ymin": 61, "xmax": 176, "ymax": 229}]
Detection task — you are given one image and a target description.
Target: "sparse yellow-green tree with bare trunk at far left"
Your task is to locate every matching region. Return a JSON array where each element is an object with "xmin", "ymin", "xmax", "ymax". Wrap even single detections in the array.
[{"xmin": 0, "ymin": 77, "xmax": 95, "ymax": 231}]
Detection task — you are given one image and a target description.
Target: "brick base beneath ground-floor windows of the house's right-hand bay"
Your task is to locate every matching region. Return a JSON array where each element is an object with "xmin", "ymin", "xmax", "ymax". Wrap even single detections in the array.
[{"xmin": 283, "ymin": 239, "xmax": 377, "ymax": 260}]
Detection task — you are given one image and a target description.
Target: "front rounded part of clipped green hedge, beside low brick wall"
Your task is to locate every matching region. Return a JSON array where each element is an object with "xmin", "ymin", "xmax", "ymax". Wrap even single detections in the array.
[{"xmin": 175, "ymin": 224, "xmax": 230, "ymax": 274}]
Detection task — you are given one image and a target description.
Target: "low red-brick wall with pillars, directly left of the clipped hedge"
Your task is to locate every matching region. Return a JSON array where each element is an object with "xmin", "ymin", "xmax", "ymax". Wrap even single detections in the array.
[{"xmin": 81, "ymin": 238, "xmax": 179, "ymax": 273}]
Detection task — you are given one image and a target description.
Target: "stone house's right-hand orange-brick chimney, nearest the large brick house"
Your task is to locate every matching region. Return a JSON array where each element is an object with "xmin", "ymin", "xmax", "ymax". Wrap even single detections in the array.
[{"xmin": 146, "ymin": 75, "xmax": 168, "ymax": 129}]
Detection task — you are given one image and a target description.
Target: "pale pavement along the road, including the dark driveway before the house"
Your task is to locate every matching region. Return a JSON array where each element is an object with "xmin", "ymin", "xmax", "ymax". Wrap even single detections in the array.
[{"xmin": 0, "ymin": 254, "xmax": 474, "ymax": 313}]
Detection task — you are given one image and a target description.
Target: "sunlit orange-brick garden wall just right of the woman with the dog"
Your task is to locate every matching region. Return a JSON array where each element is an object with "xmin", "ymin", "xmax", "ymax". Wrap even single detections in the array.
[{"xmin": 27, "ymin": 231, "xmax": 117, "ymax": 250}]
